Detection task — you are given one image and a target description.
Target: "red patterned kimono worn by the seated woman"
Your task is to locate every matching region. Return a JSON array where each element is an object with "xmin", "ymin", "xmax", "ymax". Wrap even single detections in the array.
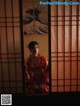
[{"xmin": 25, "ymin": 54, "xmax": 49, "ymax": 93}]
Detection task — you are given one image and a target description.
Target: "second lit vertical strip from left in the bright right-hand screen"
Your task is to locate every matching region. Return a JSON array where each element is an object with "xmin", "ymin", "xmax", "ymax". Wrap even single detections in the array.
[{"xmin": 58, "ymin": 0, "xmax": 65, "ymax": 91}]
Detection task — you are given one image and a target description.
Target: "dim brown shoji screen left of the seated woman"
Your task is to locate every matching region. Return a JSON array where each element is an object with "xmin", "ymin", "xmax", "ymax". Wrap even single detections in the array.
[{"xmin": 0, "ymin": 0, "xmax": 23, "ymax": 93}]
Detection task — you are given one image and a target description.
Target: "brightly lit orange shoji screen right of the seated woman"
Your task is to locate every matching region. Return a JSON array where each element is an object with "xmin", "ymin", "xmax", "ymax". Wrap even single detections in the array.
[{"xmin": 51, "ymin": 0, "xmax": 80, "ymax": 92}]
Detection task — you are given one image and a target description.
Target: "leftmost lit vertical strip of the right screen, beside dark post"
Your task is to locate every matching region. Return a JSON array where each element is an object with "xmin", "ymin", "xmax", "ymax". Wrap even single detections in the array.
[{"xmin": 51, "ymin": 0, "xmax": 58, "ymax": 92}]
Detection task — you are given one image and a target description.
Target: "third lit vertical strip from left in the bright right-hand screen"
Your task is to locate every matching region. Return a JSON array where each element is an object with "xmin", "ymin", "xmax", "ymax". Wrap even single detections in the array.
[{"xmin": 65, "ymin": 1, "xmax": 71, "ymax": 91}]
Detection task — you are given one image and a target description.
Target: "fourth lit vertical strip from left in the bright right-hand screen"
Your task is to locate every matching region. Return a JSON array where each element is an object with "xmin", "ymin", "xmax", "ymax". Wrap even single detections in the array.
[{"xmin": 71, "ymin": 5, "xmax": 77, "ymax": 91}]
